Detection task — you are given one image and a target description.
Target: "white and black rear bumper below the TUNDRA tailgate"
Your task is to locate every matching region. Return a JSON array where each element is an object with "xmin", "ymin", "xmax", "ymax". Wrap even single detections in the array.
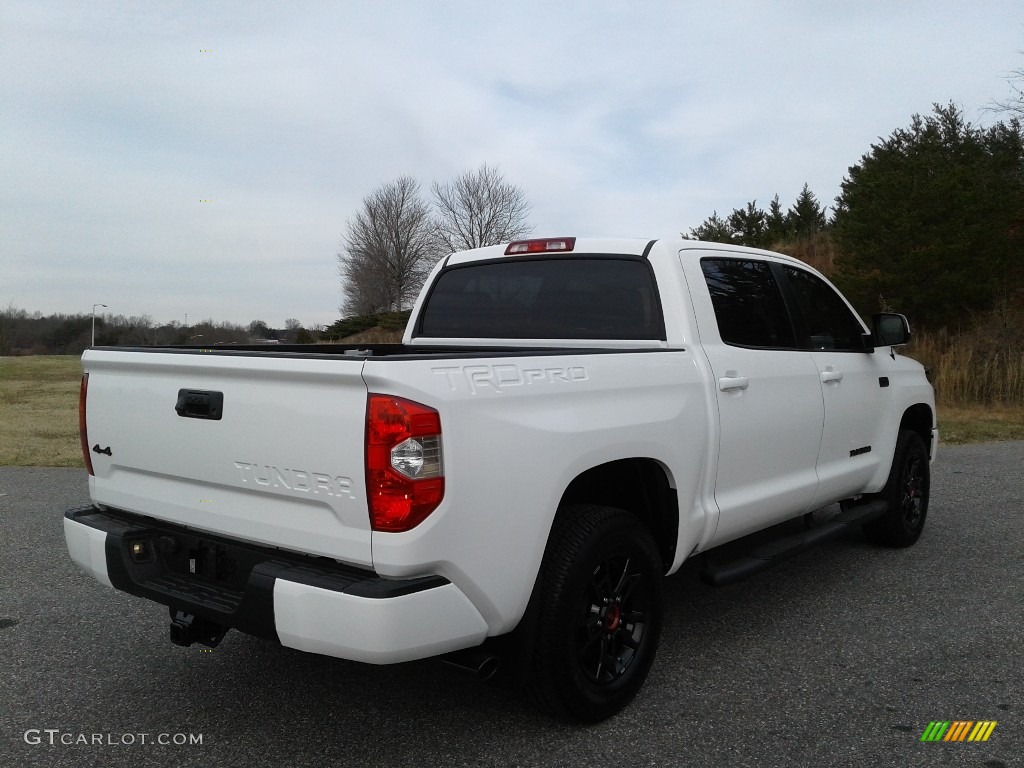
[{"xmin": 65, "ymin": 507, "xmax": 487, "ymax": 664}]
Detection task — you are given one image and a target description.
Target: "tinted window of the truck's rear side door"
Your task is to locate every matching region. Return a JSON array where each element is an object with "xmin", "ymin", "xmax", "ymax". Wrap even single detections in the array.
[{"xmin": 700, "ymin": 259, "xmax": 796, "ymax": 349}]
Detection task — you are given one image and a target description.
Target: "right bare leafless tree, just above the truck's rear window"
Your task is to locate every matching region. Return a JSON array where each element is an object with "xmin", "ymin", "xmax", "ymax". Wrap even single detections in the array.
[{"xmin": 433, "ymin": 163, "xmax": 534, "ymax": 253}]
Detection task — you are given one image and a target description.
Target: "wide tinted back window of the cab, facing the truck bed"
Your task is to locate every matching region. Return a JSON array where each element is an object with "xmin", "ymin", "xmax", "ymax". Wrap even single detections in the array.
[{"xmin": 418, "ymin": 257, "xmax": 665, "ymax": 340}]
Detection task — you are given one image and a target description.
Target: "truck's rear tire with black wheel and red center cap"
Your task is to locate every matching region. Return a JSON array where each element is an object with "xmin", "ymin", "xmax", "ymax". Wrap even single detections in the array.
[{"xmin": 527, "ymin": 505, "xmax": 663, "ymax": 723}]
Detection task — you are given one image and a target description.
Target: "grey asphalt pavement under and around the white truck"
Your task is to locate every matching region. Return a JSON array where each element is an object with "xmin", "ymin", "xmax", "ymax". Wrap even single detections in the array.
[{"xmin": 0, "ymin": 442, "xmax": 1024, "ymax": 768}]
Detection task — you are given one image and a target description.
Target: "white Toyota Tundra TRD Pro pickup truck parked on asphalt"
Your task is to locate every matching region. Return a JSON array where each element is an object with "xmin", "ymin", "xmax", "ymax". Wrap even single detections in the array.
[{"xmin": 65, "ymin": 238, "xmax": 938, "ymax": 722}]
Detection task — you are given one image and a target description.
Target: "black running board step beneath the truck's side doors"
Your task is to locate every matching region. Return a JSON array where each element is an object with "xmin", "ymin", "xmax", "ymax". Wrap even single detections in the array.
[{"xmin": 700, "ymin": 500, "xmax": 889, "ymax": 587}]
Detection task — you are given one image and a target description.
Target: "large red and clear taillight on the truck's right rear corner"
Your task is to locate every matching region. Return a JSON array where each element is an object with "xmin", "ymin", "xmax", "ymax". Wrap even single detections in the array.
[{"xmin": 367, "ymin": 394, "xmax": 444, "ymax": 534}]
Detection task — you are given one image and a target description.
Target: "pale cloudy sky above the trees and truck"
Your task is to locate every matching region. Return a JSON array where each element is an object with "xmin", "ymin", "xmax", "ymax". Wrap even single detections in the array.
[{"xmin": 0, "ymin": 0, "xmax": 1024, "ymax": 328}]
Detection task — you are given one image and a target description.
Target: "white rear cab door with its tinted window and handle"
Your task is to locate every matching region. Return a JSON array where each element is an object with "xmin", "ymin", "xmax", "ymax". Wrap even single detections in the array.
[{"xmin": 682, "ymin": 251, "xmax": 824, "ymax": 546}]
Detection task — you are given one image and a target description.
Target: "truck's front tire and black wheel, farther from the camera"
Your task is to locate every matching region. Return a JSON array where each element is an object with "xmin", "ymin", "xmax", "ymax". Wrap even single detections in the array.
[{"xmin": 864, "ymin": 429, "xmax": 930, "ymax": 547}]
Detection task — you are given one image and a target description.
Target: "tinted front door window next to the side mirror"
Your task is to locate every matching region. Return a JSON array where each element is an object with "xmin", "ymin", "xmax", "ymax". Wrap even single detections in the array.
[{"xmin": 785, "ymin": 266, "xmax": 865, "ymax": 351}]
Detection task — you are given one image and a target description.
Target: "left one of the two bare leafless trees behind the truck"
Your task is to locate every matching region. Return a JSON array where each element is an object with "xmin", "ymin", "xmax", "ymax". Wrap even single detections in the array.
[{"xmin": 338, "ymin": 176, "xmax": 438, "ymax": 315}]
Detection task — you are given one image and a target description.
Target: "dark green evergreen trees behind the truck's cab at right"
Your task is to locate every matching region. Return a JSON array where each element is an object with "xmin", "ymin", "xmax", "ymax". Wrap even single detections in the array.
[{"xmin": 684, "ymin": 103, "xmax": 1024, "ymax": 331}]
